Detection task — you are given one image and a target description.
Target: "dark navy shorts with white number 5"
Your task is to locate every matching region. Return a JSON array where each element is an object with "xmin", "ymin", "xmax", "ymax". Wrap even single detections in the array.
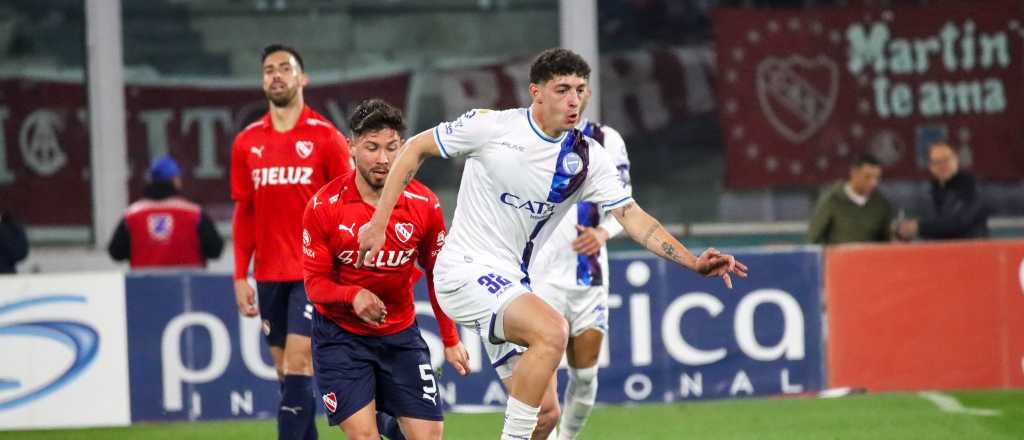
[{"xmin": 312, "ymin": 313, "xmax": 443, "ymax": 426}]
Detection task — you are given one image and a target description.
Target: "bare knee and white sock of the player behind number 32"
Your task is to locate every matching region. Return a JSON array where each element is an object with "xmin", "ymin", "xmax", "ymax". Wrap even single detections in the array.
[{"xmin": 558, "ymin": 328, "xmax": 604, "ymax": 440}]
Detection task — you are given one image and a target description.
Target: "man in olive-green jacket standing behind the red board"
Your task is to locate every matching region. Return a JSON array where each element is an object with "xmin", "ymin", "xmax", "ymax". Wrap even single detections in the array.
[{"xmin": 807, "ymin": 155, "xmax": 894, "ymax": 245}]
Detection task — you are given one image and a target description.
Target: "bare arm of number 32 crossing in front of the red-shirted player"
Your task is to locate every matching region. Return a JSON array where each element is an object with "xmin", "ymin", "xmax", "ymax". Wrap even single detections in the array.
[{"xmin": 355, "ymin": 130, "xmax": 441, "ymax": 267}]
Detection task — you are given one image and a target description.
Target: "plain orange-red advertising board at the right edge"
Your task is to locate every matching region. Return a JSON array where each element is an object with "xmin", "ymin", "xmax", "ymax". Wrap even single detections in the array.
[{"xmin": 824, "ymin": 240, "xmax": 1024, "ymax": 391}]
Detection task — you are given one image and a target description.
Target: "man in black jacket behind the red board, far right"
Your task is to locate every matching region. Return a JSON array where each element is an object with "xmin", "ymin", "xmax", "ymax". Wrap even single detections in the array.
[{"xmin": 896, "ymin": 142, "xmax": 988, "ymax": 240}]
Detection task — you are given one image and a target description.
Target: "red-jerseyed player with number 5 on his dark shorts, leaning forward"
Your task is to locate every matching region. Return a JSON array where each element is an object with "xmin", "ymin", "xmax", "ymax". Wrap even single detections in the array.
[{"xmin": 302, "ymin": 99, "xmax": 469, "ymax": 439}]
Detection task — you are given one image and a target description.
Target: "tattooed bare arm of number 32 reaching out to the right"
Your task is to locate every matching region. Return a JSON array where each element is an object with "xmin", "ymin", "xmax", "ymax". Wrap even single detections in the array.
[{"xmin": 611, "ymin": 202, "xmax": 746, "ymax": 289}]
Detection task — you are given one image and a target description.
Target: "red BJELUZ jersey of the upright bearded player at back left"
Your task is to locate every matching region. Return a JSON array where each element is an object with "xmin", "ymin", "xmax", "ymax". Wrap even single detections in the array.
[{"xmin": 231, "ymin": 106, "xmax": 352, "ymax": 281}]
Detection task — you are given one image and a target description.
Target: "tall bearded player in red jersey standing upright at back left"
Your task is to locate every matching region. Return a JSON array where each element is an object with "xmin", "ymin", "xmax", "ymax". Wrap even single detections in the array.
[{"xmin": 231, "ymin": 45, "xmax": 351, "ymax": 440}]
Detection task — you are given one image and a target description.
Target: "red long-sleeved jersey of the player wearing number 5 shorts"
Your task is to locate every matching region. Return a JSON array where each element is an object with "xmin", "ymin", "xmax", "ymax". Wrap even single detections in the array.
[{"xmin": 302, "ymin": 172, "xmax": 459, "ymax": 347}]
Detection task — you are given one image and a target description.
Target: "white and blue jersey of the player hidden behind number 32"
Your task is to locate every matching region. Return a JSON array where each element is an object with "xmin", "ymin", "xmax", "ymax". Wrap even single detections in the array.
[{"xmin": 530, "ymin": 120, "xmax": 633, "ymax": 289}]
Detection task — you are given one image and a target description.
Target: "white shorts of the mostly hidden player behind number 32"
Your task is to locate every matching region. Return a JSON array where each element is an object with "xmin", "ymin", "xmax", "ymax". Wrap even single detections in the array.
[{"xmin": 530, "ymin": 278, "xmax": 608, "ymax": 338}]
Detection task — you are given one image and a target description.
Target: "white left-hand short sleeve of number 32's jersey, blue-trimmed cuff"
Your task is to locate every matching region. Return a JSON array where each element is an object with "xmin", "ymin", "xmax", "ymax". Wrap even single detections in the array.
[{"xmin": 433, "ymin": 108, "xmax": 500, "ymax": 159}]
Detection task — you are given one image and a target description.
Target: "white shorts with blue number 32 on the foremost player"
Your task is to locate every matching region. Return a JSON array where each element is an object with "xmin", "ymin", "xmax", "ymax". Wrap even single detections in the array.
[{"xmin": 434, "ymin": 257, "xmax": 531, "ymax": 380}]
